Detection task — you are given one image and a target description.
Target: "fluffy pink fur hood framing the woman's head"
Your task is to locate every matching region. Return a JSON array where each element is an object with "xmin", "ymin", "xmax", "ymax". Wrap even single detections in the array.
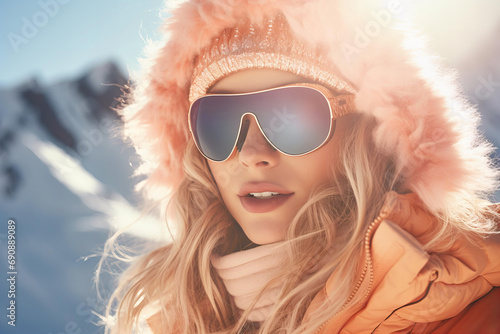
[{"xmin": 122, "ymin": 0, "xmax": 496, "ymax": 212}]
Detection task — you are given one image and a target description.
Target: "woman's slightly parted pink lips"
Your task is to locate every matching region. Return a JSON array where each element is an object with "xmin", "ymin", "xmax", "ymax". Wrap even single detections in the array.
[{"xmin": 238, "ymin": 182, "xmax": 294, "ymax": 213}]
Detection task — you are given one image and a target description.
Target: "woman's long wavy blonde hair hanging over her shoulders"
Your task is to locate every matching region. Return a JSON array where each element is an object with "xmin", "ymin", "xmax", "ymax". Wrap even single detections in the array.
[{"xmin": 99, "ymin": 114, "xmax": 494, "ymax": 334}]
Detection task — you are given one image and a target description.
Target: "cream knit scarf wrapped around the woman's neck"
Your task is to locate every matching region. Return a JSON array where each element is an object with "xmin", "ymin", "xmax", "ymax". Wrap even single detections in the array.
[{"xmin": 211, "ymin": 243, "xmax": 285, "ymax": 322}]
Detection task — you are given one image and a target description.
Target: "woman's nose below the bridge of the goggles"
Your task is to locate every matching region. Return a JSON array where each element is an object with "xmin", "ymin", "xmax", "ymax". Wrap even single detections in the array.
[{"xmin": 238, "ymin": 115, "xmax": 280, "ymax": 167}]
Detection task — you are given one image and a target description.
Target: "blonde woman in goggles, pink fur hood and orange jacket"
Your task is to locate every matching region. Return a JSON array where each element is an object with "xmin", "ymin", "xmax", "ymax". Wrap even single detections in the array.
[{"xmin": 101, "ymin": 0, "xmax": 500, "ymax": 333}]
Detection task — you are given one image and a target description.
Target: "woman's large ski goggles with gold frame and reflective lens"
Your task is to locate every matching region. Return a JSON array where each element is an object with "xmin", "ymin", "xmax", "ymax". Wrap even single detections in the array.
[{"xmin": 188, "ymin": 83, "xmax": 355, "ymax": 162}]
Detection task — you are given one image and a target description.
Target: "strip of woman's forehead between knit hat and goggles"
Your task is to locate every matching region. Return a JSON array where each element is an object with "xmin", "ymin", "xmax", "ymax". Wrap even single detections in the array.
[{"xmin": 209, "ymin": 69, "xmax": 310, "ymax": 93}]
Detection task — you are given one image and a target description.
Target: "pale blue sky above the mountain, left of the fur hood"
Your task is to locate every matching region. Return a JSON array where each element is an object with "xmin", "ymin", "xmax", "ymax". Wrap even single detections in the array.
[{"xmin": 0, "ymin": 0, "xmax": 163, "ymax": 88}]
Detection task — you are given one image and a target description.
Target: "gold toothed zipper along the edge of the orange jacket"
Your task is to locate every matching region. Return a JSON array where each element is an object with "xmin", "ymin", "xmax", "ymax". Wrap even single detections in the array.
[{"xmin": 316, "ymin": 208, "xmax": 388, "ymax": 334}]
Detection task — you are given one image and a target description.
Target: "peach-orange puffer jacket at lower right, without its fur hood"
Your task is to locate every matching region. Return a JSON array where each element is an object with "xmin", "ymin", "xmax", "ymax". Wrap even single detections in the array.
[{"xmin": 306, "ymin": 192, "xmax": 500, "ymax": 334}]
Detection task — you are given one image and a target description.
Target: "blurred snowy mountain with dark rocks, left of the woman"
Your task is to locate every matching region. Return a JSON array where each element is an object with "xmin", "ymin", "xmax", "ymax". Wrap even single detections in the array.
[{"xmin": 0, "ymin": 62, "xmax": 166, "ymax": 333}]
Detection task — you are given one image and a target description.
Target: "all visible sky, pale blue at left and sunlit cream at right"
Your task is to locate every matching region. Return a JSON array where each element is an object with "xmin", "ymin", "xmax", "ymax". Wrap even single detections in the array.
[{"xmin": 0, "ymin": 0, "xmax": 500, "ymax": 88}]
